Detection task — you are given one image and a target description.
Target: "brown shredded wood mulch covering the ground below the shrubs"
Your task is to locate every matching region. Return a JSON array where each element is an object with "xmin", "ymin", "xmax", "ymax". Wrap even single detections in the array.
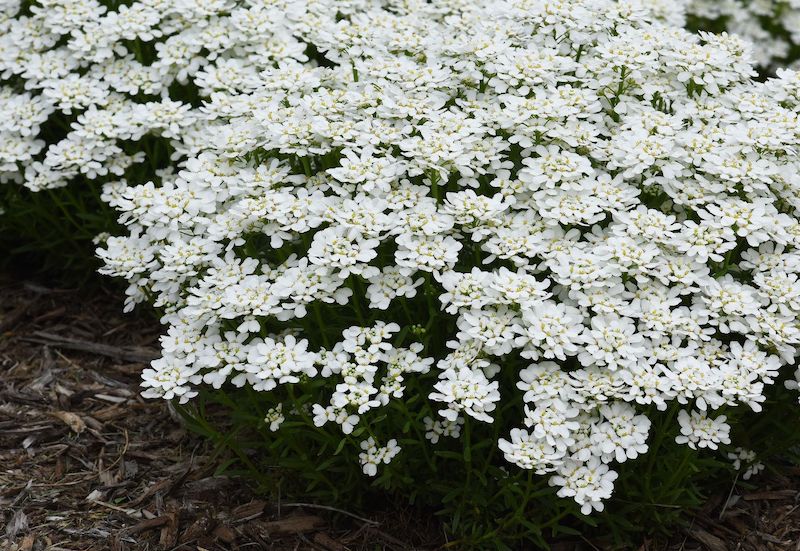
[{"xmin": 0, "ymin": 277, "xmax": 800, "ymax": 551}]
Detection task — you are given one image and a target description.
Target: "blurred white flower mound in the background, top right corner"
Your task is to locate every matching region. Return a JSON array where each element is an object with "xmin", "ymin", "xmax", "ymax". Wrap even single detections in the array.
[{"xmin": 686, "ymin": 0, "xmax": 800, "ymax": 68}]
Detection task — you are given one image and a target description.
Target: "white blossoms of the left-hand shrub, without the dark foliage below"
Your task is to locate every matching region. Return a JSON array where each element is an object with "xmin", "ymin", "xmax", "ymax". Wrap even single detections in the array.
[{"xmin": 0, "ymin": 0, "xmax": 212, "ymax": 195}]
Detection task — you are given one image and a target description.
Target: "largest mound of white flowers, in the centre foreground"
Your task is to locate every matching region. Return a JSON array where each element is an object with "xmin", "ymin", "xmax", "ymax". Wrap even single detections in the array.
[{"xmin": 87, "ymin": 0, "xmax": 800, "ymax": 513}]
